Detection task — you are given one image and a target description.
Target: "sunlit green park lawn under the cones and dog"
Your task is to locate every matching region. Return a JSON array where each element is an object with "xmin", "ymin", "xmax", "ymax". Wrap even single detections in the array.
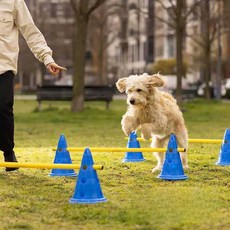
[{"xmin": 0, "ymin": 100, "xmax": 230, "ymax": 230}]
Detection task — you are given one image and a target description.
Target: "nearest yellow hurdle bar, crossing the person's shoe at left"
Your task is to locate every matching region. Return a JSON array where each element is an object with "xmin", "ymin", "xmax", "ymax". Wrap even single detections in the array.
[{"xmin": 0, "ymin": 162, "xmax": 103, "ymax": 170}]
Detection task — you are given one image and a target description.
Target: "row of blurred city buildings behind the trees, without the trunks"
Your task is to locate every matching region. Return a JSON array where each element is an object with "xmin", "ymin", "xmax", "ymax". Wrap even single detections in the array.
[{"xmin": 17, "ymin": 0, "xmax": 230, "ymax": 89}]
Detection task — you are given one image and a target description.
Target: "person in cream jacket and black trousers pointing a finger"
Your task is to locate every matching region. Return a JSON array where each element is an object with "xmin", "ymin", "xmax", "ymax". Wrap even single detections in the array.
[{"xmin": 0, "ymin": 0, "xmax": 65, "ymax": 171}]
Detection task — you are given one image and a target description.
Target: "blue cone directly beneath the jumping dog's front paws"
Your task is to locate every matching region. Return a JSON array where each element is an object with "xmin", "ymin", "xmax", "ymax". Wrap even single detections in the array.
[{"xmin": 122, "ymin": 132, "xmax": 145, "ymax": 162}]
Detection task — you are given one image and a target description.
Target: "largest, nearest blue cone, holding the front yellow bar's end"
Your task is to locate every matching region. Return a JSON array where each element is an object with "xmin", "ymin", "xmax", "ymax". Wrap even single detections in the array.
[{"xmin": 69, "ymin": 148, "xmax": 107, "ymax": 204}]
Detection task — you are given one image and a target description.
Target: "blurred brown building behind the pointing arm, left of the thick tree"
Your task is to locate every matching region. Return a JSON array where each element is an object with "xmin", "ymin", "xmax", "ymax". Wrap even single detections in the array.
[{"xmin": 16, "ymin": 0, "xmax": 74, "ymax": 91}]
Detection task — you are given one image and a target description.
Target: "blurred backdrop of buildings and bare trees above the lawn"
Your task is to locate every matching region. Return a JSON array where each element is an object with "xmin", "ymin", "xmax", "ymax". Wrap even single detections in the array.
[{"xmin": 15, "ymin": 0, "xmax": 230, "ymax": 99}]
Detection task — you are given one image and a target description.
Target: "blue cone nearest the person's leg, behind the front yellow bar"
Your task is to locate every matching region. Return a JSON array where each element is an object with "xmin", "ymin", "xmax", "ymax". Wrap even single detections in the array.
[{"xmin": 49, "ymin": 135, "xmax": 77, "ymax": 176}]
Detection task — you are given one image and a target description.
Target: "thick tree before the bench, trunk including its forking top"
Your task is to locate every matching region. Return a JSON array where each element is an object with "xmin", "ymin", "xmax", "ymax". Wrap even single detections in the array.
[{"xmin": 70, "ymin": 0, "xmax": 106, "ymax": 112}]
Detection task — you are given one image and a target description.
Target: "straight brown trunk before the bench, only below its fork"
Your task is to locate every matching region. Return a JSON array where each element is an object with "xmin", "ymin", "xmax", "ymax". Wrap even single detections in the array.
[{"xmin": 71, "ymin": 14, "xmax": 88, "ymax": 112}]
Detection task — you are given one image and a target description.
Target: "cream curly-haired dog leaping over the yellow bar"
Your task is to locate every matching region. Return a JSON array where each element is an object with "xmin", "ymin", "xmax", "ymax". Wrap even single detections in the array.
[{"xmin": 116, "ymin": 73, "xmax": 188, "ymax": 172}]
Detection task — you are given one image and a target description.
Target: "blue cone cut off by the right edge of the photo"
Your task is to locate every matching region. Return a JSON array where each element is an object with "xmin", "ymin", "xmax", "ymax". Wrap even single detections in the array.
[{"xmin": 216, "ymin": 129, "xmax": 230, "ymax": 166}]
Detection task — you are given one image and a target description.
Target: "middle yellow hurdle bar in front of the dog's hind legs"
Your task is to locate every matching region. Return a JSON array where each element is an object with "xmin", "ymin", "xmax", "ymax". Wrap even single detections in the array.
[{"xmin": 61, "ymin": 147, "xmax": 186, "ymax": 153}]
